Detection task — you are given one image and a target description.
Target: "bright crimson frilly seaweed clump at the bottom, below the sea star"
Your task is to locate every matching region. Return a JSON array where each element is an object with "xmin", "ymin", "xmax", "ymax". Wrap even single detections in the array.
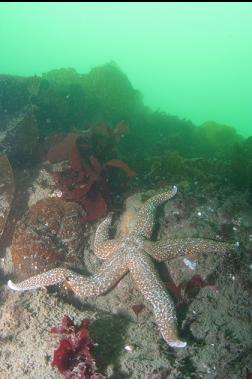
[{"xmin": 50, "ymin": 315, "xmax": 105, "ymax": 379}]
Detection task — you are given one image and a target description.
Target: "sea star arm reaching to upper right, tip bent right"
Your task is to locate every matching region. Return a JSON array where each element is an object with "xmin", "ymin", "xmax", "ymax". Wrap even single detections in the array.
[{"xmin": 134, "ymin": 186, "xmax": 177, "ymax": 238}]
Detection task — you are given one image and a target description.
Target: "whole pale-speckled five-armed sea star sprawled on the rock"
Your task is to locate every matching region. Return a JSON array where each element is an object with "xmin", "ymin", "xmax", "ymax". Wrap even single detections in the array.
[{"xmin": 8, "ymin": 186, "xmax": 230, "ymax": 347}]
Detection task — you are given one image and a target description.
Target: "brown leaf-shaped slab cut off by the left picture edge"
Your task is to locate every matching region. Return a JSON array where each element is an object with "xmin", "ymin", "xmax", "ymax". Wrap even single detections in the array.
[{"xmin": 0, "ymin": 155, "xmax": 15, "ymax": 237}]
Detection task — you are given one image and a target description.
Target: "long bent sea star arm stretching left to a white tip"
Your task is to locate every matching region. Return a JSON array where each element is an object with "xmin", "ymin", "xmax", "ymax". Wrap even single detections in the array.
[{"xmin": 8, "ymin": 254, "xmax": 128, "ymax": 298}]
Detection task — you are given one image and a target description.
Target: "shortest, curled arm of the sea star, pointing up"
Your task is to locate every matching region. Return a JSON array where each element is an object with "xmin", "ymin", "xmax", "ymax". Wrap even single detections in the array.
[{"xmin": 94, "ymin": 214, "xmax": 119, "ymax": 259}]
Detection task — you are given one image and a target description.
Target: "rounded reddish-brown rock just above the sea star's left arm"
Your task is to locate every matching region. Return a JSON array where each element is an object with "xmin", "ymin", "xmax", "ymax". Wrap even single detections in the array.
[{"xmin": 11, "ymin": 198, "xmax": 83, "ymax": 280}]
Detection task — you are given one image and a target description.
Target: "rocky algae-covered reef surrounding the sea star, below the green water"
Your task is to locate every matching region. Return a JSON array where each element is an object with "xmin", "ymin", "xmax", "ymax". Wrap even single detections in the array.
[{"xmin": 0, "ymin": 63, "xmax": 252, "ymax": 379}]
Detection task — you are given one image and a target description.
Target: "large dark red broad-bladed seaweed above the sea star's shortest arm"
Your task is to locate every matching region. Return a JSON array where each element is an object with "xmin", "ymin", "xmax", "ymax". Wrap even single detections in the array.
[{"xmin": 47, "ymin": 123, "xmax": 136, "ymax": 223}]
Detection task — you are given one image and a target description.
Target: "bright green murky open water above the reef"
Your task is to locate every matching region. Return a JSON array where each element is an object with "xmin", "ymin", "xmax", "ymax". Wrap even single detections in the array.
[{"xmin": 0, "ymin": 3, "xmax": 252, "ymax": 136}]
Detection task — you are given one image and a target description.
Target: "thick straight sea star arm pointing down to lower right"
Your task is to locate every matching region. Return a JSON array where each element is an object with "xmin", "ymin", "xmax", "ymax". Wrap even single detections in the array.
[{"xmin": 128, "ymin": 251, "xmax": 186, "ymax": 347}]
